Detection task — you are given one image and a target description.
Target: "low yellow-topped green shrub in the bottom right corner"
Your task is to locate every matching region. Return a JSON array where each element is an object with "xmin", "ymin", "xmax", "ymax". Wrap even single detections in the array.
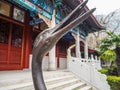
[{"xmin": 107, "ymin": 76, "xmax": 120, "ymax": 90}]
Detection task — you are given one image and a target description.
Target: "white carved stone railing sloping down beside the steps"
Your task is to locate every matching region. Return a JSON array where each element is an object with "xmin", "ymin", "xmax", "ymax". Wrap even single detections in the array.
[{"xmin": 67, "ymin": 46, "xmax": 110, "ymax": 90}]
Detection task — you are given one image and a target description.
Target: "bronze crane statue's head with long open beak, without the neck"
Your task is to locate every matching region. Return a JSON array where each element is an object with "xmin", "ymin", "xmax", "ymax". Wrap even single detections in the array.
[{"xmin": 33, "ymin": 0, "xmax": 95, "ymax": 55}]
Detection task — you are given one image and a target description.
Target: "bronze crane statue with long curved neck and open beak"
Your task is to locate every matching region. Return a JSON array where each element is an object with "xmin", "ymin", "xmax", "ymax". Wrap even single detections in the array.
[{"xmin": 32, "ymin": 1, "xmax": 95, "ymax": 90}]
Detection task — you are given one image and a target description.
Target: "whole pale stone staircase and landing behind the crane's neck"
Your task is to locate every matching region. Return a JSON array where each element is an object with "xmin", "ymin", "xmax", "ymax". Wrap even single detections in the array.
[{"xmin": 0, "ymin": 70, "xmax": 95, "ymax": 90}]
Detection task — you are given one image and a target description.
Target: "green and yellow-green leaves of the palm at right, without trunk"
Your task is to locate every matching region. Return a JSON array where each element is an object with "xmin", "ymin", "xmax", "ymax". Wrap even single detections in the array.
[{"xmin": 99, "ymin": 32, "xmax": 120, "ymax": 61}]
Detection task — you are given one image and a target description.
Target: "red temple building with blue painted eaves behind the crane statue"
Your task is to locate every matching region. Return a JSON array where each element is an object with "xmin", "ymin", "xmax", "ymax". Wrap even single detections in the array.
[{"xmin": 0, "ymin": 0, "xmax": 104, "ymax": 70}]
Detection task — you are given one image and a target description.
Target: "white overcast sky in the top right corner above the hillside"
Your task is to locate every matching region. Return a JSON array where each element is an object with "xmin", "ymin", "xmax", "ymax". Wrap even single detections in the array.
[{"xmin": 87, "ymin": 0, "xmax": 120, "ymax": 15}]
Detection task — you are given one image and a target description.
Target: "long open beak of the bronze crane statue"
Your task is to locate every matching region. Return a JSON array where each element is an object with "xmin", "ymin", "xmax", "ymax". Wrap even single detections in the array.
[{"xmin": 50, "ymin": 0, "xmax": 96, "ymax": 44}]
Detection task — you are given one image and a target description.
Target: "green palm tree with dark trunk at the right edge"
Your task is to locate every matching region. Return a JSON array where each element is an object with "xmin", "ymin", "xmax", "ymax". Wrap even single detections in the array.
[{"xmin": 99, "ymin": 32, "xmax": 120, "ymax": 76}]
